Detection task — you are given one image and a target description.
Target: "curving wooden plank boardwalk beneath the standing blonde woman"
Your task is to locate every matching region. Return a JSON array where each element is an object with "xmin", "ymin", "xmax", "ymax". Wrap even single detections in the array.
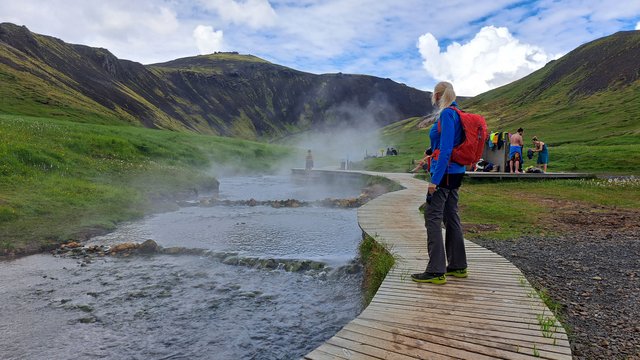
[{"xmin": 304, "ymin": 172, "xmax": 572, "ymax": 360}]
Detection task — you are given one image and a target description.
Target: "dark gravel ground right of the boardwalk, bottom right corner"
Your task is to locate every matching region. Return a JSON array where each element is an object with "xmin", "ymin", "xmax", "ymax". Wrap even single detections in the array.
[{"xmin": 473, "ymin": 228, "xmax": 640, "ymax": 359}]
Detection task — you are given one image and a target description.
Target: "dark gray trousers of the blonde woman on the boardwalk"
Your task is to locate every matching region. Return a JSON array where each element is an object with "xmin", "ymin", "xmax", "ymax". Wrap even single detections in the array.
[{"xmin": 424, "ymin": 187, "xmax": 467, "ymax": 274}]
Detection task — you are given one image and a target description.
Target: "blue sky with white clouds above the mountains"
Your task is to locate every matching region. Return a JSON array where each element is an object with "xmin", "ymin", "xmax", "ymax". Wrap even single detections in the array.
[{"xmin": 0, "ymin": 0, "xmax": 640, "ymax": 96}]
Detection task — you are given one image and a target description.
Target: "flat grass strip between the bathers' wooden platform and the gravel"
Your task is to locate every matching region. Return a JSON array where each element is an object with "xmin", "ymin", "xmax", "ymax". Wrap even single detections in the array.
[{"xmin": 459, "ymin": 179, "xmax": 640, "ymax": 239}]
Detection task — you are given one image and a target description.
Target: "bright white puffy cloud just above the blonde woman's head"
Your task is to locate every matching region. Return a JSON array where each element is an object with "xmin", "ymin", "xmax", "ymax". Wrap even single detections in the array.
[{"xmin": 417, "ymin": 26, "xmax": 555, "ymax": 96}]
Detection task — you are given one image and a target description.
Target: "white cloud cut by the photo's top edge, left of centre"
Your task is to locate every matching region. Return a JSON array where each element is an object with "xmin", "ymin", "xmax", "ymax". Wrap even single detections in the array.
[{"xmin": 201, "ymin": 0, "xmax": 277, "ymax": 29}]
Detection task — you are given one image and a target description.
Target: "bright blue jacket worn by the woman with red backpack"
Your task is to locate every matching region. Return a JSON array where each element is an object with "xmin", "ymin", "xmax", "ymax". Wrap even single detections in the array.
[{"xmin": 429, "ymin": 101, "xmax": 466, "ymax": 185}]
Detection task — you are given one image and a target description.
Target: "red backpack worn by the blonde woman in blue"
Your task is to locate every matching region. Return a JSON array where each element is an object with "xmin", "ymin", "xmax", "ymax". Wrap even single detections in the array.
[{"xmin": 436, "ymin": 106, "xmax": 487, "ymax": 166}]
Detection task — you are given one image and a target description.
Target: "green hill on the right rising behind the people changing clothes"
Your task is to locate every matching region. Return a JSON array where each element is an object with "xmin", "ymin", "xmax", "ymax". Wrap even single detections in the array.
[{"xmin": 370, "ymin": 31, "xmax": 640, "ymax": 174}]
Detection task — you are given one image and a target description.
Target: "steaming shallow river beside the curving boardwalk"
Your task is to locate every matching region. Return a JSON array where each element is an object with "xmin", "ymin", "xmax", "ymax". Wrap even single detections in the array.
[{"xmin": 0, "ymin": 176, "xmax": 362, "ymax": 359}]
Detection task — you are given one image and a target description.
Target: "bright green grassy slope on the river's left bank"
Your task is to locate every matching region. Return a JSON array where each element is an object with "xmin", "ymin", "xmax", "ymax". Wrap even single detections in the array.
[{"xmin": 0, "ymin": 115, "xmax": 291, "ymax": 255}]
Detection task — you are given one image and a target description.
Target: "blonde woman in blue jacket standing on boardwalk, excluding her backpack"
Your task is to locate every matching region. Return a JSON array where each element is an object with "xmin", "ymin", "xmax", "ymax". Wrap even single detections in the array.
[{"xmin": 411, "ymin": 82, "xmax": 467, "ymax": 284}]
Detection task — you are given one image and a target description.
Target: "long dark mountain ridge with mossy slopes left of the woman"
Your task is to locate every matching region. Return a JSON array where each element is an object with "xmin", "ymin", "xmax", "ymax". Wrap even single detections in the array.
[{"xmin": 0, "ymin": 23, "xmax": 432, "ymax": 139}]
